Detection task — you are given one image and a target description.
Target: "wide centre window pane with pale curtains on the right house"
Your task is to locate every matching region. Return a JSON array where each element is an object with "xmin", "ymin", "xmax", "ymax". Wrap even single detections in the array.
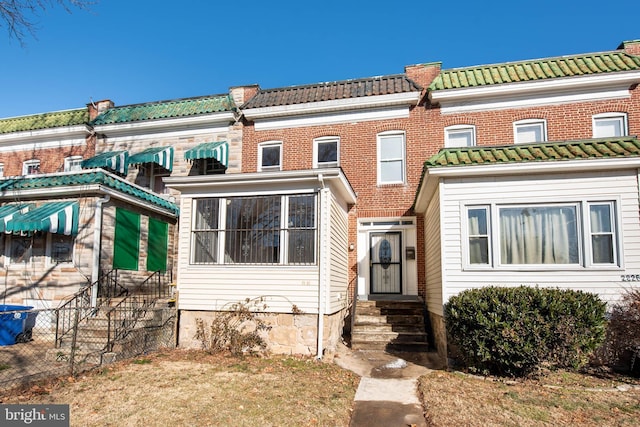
[{"xmin": 500, "ymin": 206, "xmax": 579, "ymax": 264}]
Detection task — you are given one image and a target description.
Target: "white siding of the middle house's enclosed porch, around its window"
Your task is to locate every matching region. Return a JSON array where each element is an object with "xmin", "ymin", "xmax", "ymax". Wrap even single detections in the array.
[{"xmin": 177, "ymin": 185, "xmax": 349, "ymax": 314}]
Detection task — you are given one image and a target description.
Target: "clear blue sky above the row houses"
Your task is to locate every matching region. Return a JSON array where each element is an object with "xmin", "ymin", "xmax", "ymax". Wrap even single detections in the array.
[{"xmin": 0, "ymin": 0, "xmax": 640, "ymax": 118}]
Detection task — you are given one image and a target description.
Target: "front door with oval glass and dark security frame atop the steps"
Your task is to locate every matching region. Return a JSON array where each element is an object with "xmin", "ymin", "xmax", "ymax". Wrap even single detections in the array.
[{"xmin": 369, "ymin": 232, "xmax": 402, "ymax": 294}]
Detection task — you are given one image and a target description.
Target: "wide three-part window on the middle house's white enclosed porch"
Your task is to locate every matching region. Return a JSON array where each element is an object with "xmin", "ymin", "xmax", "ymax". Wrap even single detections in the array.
[{"xmin": 191, "ymin": 195, "xmax": 317, "ymax": 265}]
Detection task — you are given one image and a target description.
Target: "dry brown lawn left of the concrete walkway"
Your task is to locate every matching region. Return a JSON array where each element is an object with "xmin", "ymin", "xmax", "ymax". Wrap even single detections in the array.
[{"xmin": 0, "ymin": 350, "xmax": 358, "ymax": 426}]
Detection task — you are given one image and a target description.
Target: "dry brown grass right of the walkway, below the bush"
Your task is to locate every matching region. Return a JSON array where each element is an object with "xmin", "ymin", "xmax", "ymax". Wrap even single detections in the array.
[{"xmin": 419, "ymin": 371, "xmax": 640, "ymax": 427}]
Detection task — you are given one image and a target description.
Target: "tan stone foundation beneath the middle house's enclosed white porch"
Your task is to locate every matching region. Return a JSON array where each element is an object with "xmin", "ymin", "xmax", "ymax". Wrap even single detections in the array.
[{"xmin": 178, "ymin": 309, "xmax": 347, "ymax": 356}]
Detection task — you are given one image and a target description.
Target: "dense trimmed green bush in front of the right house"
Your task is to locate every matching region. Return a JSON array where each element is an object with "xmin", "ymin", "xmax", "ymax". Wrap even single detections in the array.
[{"xmin": 444, "ymin": 286, "xmax": 606, "ymax": 376}]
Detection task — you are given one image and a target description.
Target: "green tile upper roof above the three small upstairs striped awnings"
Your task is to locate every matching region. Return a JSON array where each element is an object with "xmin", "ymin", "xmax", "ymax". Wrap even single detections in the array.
[{"xmin": 92, "ymin": 95, "xmax": 235, "ymax": 125}]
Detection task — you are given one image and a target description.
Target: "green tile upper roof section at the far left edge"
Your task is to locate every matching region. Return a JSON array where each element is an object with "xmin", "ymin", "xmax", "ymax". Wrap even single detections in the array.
[{"xmin": 0, "ymin": 108, "xmax": 89, "ymax": 134}]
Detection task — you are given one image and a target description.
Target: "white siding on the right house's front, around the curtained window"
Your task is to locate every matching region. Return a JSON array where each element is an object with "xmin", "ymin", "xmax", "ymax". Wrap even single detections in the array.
[{"xmin": 440, "ymin": 171, "xmax": 640, "ymax": 303}]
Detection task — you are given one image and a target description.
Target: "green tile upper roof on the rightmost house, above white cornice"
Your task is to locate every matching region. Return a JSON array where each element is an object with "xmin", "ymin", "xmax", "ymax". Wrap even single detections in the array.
[{"xmin": 429, "ymin": 51, "xmax": 640, "ymax": 91}]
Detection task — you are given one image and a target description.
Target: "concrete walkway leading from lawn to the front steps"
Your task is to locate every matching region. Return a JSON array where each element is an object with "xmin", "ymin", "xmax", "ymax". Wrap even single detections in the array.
[{"xmin": 334, "ymin": 345, "xmax": 443, "ymax": 427}]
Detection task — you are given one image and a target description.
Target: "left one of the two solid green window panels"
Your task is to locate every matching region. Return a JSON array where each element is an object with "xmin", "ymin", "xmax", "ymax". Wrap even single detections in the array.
[{"xmin": 113, "ymin": 208, "xmax": 140, "ymax": 270}]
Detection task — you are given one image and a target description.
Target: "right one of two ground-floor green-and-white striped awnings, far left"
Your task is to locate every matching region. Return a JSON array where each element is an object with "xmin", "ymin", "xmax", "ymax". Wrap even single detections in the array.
[{"xmin": 6, "ymin": 201, "xmax": 79, "ymax": 236}]
